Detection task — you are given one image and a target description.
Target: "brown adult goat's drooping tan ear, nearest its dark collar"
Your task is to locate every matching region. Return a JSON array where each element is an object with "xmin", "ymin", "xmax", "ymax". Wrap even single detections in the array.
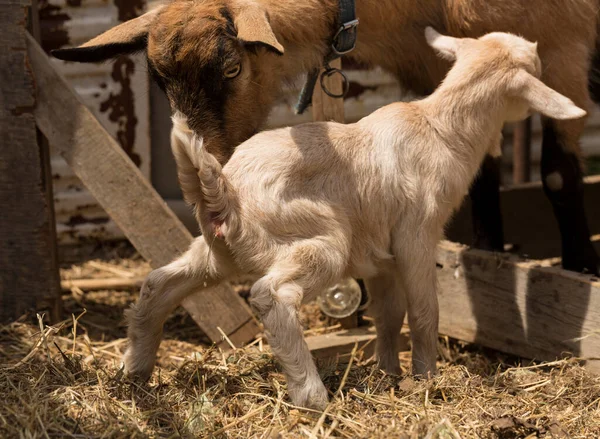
[{"xmin": 233, "ymin": 2, "xmax": 284, "ymax": 55}]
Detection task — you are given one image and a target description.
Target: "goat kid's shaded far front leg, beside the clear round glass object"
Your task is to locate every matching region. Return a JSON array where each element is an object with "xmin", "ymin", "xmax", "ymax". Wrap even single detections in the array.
[{"xmin": 365, "ymin": 272, "xmax": 406, "ymax": 375}]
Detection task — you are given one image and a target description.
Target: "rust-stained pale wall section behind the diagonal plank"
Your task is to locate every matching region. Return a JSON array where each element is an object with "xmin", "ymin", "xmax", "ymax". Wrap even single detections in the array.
[{"xmin": 39, "ymin": 0, "xmax": 150, "ymax": 244}]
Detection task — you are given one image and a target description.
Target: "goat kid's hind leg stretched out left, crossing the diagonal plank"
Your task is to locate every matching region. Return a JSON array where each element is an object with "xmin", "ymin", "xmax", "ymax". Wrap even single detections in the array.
[{"xmin": 123, "ymin": 237, "xmax": 233, "ymax": 380}]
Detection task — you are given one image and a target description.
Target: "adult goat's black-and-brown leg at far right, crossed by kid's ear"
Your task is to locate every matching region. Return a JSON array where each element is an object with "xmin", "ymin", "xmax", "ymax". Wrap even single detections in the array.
[{"xmin": 541, "ymin": 46, "xmax": 600, "ymax": 275}]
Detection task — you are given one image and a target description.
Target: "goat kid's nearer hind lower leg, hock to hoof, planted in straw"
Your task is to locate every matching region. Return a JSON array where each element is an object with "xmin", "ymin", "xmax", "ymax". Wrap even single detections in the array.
[{"xmin": 250, "ymin": 275, "xmax": 328, "ymax": 410}]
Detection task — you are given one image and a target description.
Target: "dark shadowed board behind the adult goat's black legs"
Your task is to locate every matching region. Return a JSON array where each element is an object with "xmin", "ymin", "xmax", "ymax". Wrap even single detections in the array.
[{"xmin": 446, "ymin": 175, "xmax": 600, "ymax": 259}]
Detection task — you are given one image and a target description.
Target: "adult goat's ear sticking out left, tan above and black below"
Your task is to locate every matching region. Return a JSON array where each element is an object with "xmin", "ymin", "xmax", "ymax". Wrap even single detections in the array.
[{"xmin": 51, "ymin": 6, "xmax": 164, "ymax": 62}]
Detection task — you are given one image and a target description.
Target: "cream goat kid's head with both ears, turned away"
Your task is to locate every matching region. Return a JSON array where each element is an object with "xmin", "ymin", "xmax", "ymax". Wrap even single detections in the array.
[{"xmin": 425, "ymin": 27, "xmax": 587, "ymax": 122}]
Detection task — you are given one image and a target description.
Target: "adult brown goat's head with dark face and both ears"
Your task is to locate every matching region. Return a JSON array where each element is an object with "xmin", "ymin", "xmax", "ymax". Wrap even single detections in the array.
[{"xmin": 53, "ymin": 0, "xmax": 284, "ymax": 163}]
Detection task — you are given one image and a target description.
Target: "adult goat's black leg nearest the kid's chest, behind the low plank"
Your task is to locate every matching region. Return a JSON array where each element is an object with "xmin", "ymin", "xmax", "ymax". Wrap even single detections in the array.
[{"xmin": 469, "ymin": 155, "xmax": 504, "ymax": 252}]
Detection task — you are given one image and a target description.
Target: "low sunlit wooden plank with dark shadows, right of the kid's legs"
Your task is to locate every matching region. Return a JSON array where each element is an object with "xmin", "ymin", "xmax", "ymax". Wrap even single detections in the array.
[{"xmin": 438, "ymin": 241, "xmax": 600, "ymax": 370}]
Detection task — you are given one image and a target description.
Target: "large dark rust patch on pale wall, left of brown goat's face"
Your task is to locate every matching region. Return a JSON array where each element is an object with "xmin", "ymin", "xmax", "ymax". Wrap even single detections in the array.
[{"xmin": 100, "ymin": 56, "xmax": 141, "ymax": 166}]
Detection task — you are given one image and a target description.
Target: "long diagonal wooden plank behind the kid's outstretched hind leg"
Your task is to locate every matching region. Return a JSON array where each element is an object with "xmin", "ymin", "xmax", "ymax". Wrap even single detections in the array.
[{"xmin": 27, "ymin": 32, "xmax": 258, "ymax": 342}]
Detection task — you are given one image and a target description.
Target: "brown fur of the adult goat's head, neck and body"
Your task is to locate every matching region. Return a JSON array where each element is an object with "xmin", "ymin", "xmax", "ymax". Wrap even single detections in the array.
[{"xmin": 52, "ymin": 0, "xmax": 599, "ymax": 163}]
